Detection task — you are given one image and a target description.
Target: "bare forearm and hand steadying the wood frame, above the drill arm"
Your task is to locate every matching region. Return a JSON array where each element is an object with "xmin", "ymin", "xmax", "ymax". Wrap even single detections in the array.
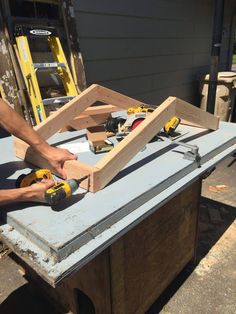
[{"xmin": 0, "ymin": 99, "xmax": 76, "ymax": 178}]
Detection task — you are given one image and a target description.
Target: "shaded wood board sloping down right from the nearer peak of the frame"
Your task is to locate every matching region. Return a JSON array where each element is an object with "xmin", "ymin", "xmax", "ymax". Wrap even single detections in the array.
[{"xmin": 175, "ymin": 98, "xmax": 220, "ymax": 130}]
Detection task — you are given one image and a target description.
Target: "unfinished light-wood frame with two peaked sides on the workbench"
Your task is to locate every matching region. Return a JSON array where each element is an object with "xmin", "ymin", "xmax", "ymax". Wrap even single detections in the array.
[{"xmin": 14, "ymin": 84, "xmax": 219, "ymax": 192}]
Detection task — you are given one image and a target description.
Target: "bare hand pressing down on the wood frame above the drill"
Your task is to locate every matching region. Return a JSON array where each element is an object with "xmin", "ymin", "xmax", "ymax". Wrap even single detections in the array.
[{"xmin": 42, "ymin": 146, "xmax": 76, "ymax": 179}]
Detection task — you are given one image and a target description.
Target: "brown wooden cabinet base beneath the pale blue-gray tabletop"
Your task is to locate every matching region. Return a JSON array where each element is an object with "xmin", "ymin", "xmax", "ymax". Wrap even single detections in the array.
[{"xmin": 28, "ymin": 180, "xmax": 201, "ymax": 314}]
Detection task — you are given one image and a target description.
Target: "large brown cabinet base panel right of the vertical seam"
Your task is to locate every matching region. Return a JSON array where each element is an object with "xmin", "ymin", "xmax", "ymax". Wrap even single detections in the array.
[{"xmin": 110, "ymin": 180, "xmax": 201, "ymax": 314}]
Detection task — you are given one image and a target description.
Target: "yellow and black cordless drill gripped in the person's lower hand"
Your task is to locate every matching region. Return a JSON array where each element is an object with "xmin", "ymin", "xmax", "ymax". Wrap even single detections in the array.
[{"xmin": 16, "ymin": 169, "xmax": 88, "ymax": 205}]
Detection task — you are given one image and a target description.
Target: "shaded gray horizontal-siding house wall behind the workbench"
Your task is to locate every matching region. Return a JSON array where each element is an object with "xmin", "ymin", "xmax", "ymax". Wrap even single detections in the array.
[{"xmin": 75, "ymin": 0, "xmax": 236, "ymax": 104}]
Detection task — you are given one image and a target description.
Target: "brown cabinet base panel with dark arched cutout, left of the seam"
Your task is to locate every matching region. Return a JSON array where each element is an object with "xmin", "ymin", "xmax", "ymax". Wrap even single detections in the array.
[{"xmin": 22, "ymin": 249, "xmax": 111, "ymax": 314}]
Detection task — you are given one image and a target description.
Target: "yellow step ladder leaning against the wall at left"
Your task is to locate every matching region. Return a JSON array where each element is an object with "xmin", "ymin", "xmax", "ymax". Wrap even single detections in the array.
[{"xmin": 14, "ymin": 25, "xmax": 78, "ymax": 124}]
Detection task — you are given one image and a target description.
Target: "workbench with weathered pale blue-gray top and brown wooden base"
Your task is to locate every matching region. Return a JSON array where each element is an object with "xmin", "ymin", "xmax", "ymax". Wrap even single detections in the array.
[{"xmin": 0, "ymin": 122, "xmax": 236, "ymax": 314}]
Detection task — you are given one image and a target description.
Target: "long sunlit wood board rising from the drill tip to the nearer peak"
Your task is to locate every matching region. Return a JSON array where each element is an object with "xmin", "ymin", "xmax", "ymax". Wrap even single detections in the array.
[{"xmin": 94, "ymin": 97, "xmax": 176, "ymax": 190}]
